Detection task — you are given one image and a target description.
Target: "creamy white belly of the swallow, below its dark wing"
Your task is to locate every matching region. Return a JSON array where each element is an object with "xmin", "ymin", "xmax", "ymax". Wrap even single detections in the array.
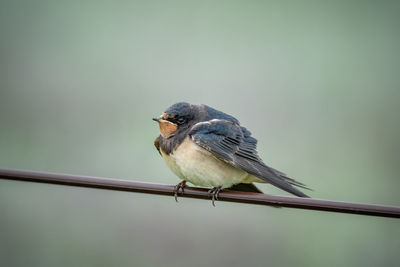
[{"xmin": 161, "ymin": 138, "xmax": 260, "ymax": 188}]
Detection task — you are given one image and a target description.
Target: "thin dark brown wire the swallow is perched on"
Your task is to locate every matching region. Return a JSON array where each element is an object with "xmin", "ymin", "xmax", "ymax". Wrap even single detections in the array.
[{"xmin": 0, "ymin": 168, "xmax": 400, "ymax": 218}]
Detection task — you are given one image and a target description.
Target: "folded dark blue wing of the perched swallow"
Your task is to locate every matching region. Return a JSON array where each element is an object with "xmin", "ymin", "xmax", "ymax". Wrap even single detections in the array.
[{"xmin": 189, "ymin": 119, "xmax": 308, "ymax": 197}]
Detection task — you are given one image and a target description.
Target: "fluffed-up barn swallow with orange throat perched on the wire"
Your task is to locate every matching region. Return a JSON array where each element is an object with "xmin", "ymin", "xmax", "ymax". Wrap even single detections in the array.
[{"xmin": 153, "ymin": 102, "xmax": 309, "ymax": 205}]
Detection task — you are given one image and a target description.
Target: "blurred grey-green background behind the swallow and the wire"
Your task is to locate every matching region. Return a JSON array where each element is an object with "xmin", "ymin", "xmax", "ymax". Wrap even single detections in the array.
[{"xmin": 0, "ymin": 0, "xmax": 400, "ymax": 266}]
